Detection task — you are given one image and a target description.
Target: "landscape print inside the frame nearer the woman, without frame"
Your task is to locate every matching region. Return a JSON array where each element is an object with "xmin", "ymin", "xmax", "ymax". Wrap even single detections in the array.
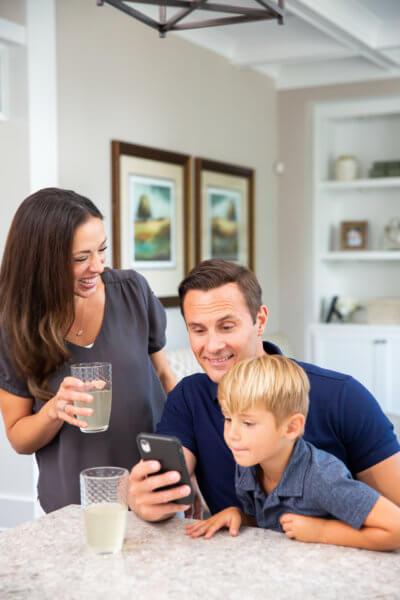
[{"xmin": 130, "ymin": 175, "xmax": 176, "ymax": 269}]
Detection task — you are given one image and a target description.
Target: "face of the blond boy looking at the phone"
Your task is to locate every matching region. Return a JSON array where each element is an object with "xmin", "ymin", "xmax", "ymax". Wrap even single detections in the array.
[{"xmin": 223, "ymin": 408, "xmax": 288, "ymax": 467}]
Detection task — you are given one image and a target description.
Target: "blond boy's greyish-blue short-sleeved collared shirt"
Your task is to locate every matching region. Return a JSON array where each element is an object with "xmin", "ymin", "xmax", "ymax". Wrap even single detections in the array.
[{"xmin": 235, "ymin": 439, "xmax": 379, "ymax": 531}]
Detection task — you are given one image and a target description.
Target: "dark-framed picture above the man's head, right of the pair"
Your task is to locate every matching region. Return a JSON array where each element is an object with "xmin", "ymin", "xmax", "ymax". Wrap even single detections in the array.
[{"xmin": 195, "ymin": 158, "xmax": 254, "ymax": 269}]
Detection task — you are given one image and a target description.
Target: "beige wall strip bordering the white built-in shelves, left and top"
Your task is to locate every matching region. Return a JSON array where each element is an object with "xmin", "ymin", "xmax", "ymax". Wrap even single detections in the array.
[{"xmin": 278, "ymin": 79, "xmax": 400, "ymax": 358}]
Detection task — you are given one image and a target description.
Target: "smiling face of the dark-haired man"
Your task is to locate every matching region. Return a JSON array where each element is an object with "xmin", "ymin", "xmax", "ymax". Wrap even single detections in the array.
[{"xmin": 183, "ymin": 283, "xmax": 268, "ymax": 383}]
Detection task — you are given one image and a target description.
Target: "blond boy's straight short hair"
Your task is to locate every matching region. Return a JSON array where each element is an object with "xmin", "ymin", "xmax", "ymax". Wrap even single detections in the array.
[{"xmin": 218, "ymin": 354, "xmax": 310, "ymax": 426}]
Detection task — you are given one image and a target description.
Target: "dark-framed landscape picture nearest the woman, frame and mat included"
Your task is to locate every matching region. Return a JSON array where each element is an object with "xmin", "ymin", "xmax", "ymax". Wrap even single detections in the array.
[{"xmin": 111, "ymin": 141, "xmax": 190, "ymax": 306}]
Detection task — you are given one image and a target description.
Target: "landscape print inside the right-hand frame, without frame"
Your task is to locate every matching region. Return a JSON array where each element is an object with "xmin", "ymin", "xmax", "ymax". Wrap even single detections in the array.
[{"xmin": 207, "ymin": 187, "xmax": 242, "ymax": 261}]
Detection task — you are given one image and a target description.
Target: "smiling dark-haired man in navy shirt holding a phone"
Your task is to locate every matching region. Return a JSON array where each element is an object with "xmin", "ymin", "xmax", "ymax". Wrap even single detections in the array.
[{"xmin": 129, "ymin": 259, "xmax": 400, "ymax": 521}]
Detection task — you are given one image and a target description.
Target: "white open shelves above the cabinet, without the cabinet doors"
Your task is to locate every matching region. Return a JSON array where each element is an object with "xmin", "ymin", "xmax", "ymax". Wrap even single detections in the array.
[{"xmin": 313, "ymin": 97, "xmax": 400, "ymax": 323}]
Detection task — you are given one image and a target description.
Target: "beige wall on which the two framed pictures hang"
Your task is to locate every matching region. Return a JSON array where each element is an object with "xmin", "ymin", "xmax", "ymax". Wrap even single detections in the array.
[{"xmin": 56, "ymin": 0, "xmax": 279, "ymax": 347}]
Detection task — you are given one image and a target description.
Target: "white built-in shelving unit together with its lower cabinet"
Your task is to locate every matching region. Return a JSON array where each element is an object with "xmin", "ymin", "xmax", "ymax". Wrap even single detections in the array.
[{"xmin": 308, "ymin": 97, "xmax": 400, "ymax": 414}]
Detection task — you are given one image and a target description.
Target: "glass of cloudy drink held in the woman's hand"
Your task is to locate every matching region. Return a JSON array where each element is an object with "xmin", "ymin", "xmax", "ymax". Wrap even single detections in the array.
[{"xmin": 71, "ymin": 362, "xmax": 112, "ymax": 433}]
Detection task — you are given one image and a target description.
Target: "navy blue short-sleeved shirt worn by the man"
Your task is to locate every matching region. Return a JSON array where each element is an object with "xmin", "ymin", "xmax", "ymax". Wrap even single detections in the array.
[{"xmin": 157, "ymin": 343, "xmax": 400, "ymax": 513}]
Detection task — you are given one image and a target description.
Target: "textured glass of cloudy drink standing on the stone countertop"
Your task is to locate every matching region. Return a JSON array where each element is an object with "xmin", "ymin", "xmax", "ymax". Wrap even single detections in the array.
[{"xmin": 80, "ymin": 467, "xmax": 129, "ymax": 554}]
